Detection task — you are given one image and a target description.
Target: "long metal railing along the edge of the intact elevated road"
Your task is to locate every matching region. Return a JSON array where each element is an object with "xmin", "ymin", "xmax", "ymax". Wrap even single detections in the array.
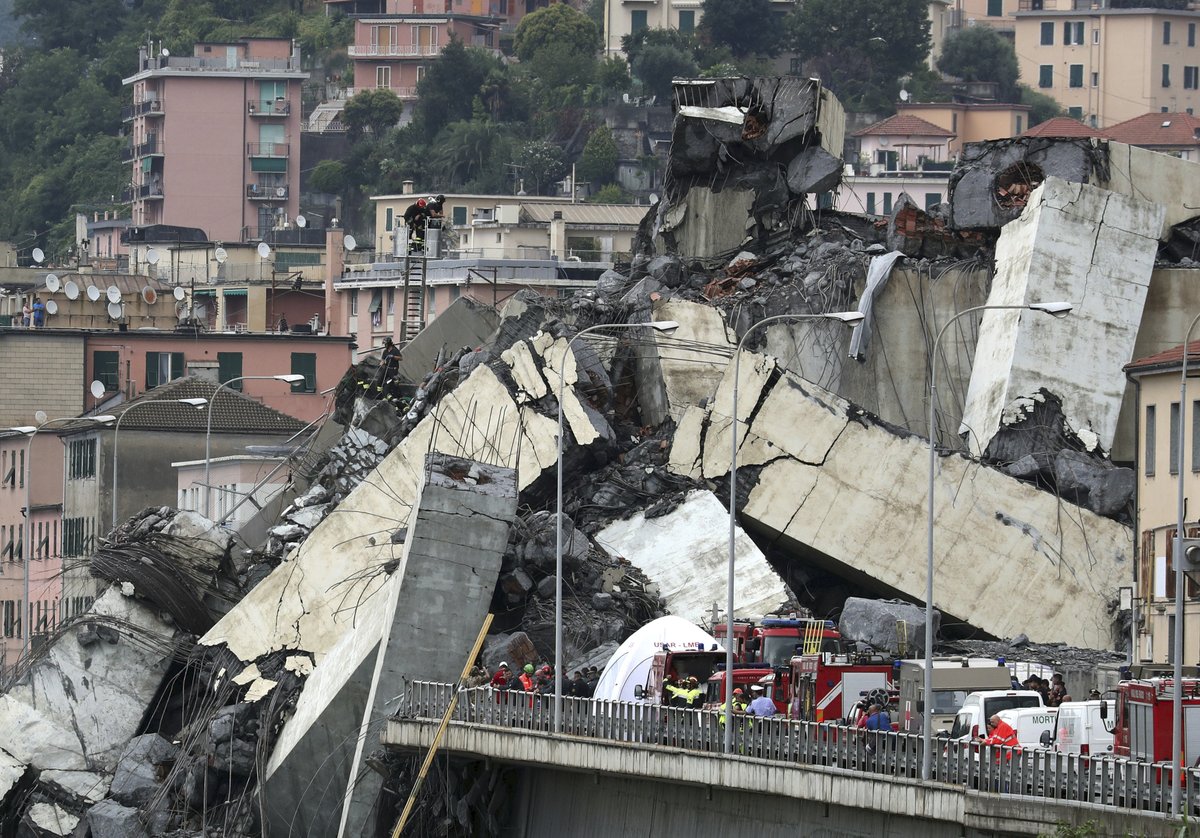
[{"xmin": 396, "ymin": 681, "xmax": 1200, "ymax": 816}]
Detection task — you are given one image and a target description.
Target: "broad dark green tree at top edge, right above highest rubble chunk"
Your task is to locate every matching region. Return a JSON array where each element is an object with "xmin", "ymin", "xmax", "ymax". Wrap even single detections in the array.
[{"xmin": 787, "ymin": 0, "xmax": 930, "ymax": 110}]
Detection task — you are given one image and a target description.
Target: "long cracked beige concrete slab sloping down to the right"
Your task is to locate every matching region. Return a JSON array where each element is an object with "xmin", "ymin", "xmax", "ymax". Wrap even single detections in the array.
[{"xmin": 672, "ymin": 361, "xmax": 1133, "ymax": 648}]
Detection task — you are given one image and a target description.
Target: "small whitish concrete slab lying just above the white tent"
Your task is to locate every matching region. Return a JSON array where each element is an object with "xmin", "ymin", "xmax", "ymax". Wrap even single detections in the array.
[{"xmin": 596, "ymin": 491, "xmax": 791, "ymax": 624}]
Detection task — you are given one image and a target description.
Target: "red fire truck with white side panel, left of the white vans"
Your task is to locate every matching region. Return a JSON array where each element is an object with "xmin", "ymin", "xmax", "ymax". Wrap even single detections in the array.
[{"xmin": 788, "ymin": 652, "xmax": 895, "ymax": 722}]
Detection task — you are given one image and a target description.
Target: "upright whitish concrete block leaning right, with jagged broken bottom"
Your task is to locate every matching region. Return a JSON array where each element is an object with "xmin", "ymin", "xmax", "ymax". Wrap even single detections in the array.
[{"xmin": 961, "ymin": 178, "xmax": 1164, "ymax": 454}]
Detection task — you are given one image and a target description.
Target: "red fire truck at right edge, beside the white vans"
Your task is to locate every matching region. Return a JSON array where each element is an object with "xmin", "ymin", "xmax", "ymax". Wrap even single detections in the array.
[{"xmin": 1102, "ymin": 678, "xmax": 1200, "ymax": 767}]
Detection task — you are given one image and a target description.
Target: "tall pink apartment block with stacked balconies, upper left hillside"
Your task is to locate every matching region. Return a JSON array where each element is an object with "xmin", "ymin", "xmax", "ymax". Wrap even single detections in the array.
[{"xmin": 122, "ymin": 38, "xmax": 308, "ymax": 241}]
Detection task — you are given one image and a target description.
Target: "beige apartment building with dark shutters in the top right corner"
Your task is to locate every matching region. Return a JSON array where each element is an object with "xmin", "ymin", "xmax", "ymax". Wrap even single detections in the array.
[{"xmin": 1015, "ymin": 0, "xmax": 1200, "ymax": 128}]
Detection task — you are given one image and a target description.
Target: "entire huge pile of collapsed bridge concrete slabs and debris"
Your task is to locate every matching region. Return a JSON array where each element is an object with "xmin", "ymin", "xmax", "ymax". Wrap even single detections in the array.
[{"xmin": 11, "ymin": 78, "xmax": 1200, "ymax": 836}]
